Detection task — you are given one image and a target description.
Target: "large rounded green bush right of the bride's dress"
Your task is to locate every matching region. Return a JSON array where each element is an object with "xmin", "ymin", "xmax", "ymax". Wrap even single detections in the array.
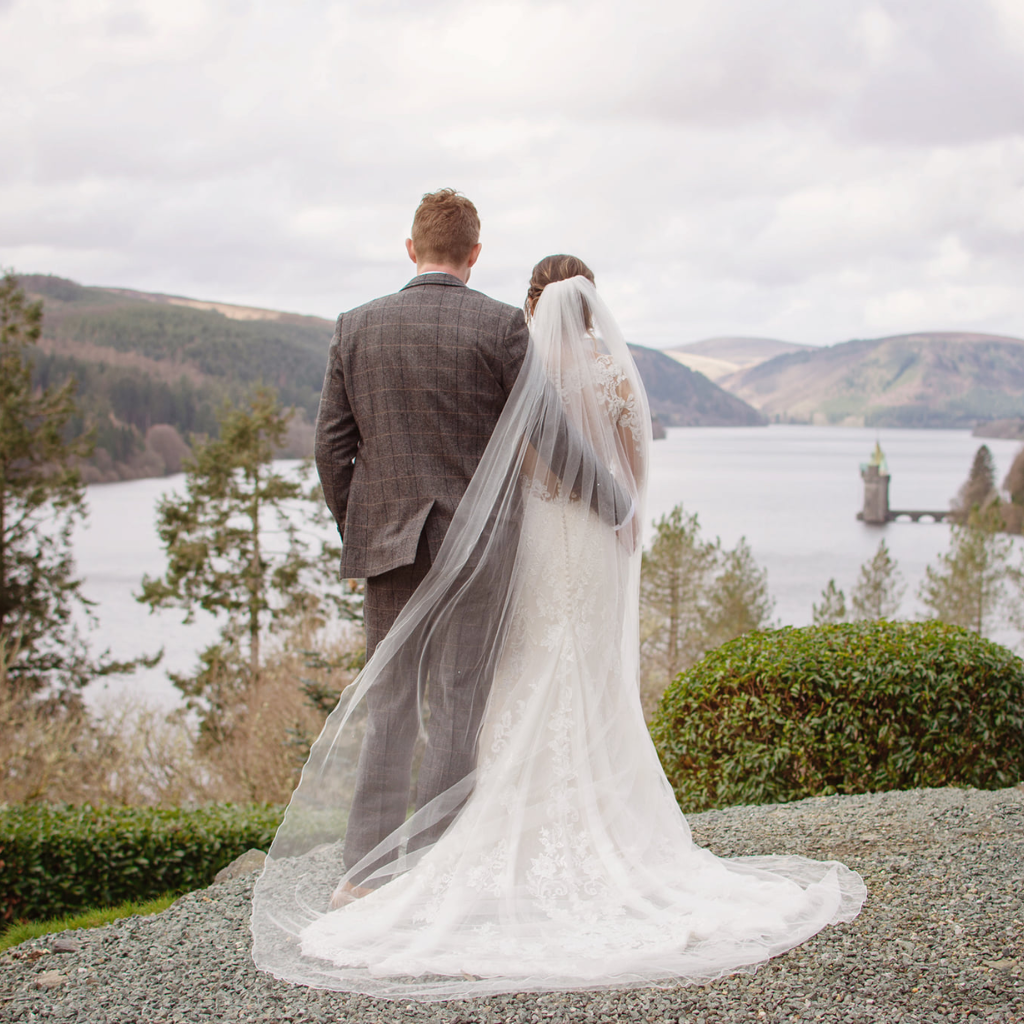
[{"xmin": 651, "ymin": 622, "xmax": 1024, "ymax": 811}]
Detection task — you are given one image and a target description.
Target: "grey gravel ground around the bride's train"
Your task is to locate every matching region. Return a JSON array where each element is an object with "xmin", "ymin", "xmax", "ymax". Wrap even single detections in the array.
[{"xmin": 0, "ymin": 785, "xmax": 1024, "ymax": 1024}]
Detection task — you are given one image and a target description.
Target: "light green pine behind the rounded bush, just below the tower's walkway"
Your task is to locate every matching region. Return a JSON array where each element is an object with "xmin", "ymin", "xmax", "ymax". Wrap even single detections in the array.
[{"xmin": 919, "ymin": 508, "xmax": 1016, "ymax": 636}]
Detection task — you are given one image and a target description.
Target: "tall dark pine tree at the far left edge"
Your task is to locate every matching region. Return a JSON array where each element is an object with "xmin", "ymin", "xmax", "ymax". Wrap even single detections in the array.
[{"xmin": 0, "ymin": 271, "xmax": 97, "ymax": 703}]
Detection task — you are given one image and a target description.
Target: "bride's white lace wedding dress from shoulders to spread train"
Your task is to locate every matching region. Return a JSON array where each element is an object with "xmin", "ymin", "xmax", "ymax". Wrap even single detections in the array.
[{"xmin": 247, "ymin": 279, "xmax": 865, "ymax": 999}]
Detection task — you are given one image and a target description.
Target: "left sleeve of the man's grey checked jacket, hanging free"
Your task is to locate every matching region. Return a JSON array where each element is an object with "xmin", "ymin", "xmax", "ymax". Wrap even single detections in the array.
[{"xmin": 313, "ymin": 316, "xmax": 360, "ymax": 535}]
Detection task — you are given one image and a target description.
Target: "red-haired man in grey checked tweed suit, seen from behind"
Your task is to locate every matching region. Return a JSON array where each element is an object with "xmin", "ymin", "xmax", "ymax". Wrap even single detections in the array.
[{"xmin": 315, "ymin": 188, "xmax": 629, "ymax": 895}]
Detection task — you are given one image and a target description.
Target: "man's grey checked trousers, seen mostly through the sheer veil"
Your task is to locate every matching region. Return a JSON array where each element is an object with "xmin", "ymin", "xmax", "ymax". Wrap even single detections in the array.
[{"xmin": 344, "ymin": 537, "xmax": 493, "ymax": 884}]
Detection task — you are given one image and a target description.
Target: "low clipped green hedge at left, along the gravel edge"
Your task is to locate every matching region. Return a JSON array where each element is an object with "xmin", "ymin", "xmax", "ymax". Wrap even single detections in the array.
[{"xmin": 0, "ymin": 804, "xmax": 284, "ymax": 922}]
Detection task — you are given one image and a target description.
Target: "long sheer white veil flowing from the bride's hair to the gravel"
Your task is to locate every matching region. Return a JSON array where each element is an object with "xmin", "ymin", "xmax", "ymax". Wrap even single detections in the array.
[{"xmin": 252, "ymin": 278, "xmax": 650, "ymax": 994}]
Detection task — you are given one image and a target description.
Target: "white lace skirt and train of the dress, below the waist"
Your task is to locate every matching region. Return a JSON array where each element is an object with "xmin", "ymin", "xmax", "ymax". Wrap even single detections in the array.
[{"xmin": 301, "ymin": 389, "xmax": 865, "ymax": 994}]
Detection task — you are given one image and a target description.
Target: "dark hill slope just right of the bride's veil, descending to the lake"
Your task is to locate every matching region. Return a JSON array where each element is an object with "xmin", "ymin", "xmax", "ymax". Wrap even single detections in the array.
[{"xmin": 630, "ymin": 345, "xmax": 767, "ymax": 427}]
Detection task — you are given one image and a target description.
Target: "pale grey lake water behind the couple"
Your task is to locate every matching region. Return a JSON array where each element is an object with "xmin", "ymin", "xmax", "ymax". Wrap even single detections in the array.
[{"xmin": 75, "ymin": 426, "xmax": 1020, "ymax": 706}]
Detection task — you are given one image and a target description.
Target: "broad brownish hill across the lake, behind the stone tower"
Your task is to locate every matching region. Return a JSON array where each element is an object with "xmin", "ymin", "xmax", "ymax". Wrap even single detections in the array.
[{"xmin": 720, "ymin": 332, "xmax": 1024, "ymax": 428}]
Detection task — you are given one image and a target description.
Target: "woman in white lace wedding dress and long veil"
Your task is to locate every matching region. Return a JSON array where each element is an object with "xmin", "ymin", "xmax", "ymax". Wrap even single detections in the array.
[{"xmin": 252, "ymin": 256, "xmax": 866, "ymax": 999}]
